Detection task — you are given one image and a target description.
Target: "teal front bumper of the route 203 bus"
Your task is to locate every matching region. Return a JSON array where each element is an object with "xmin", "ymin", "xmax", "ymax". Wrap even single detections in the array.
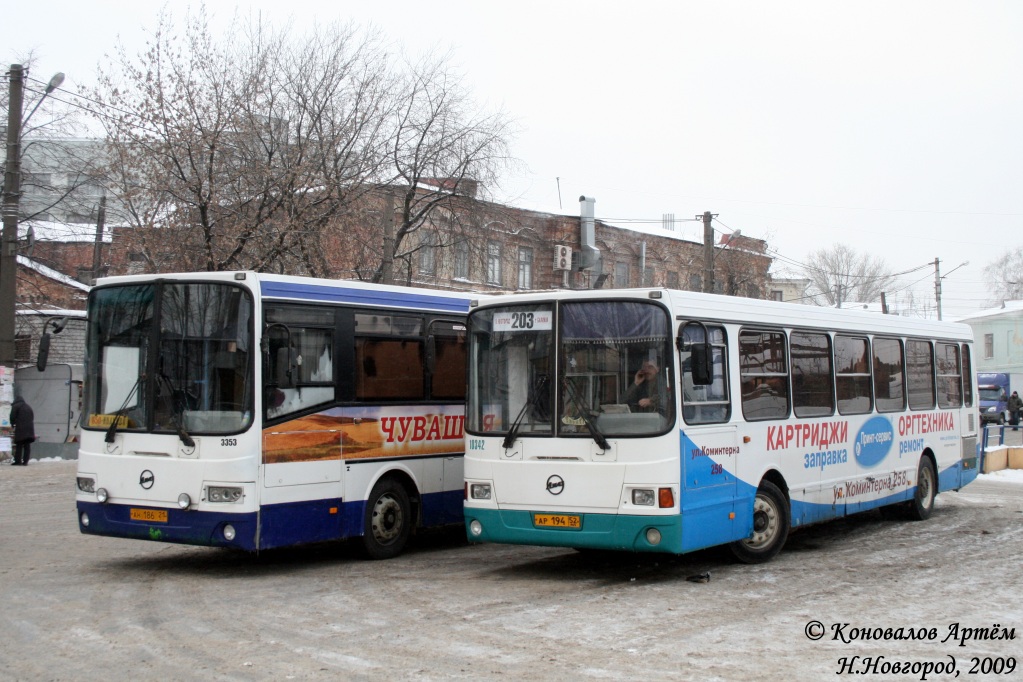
[{"xmin": 465, "ymin": 508, "xmax": 682, "ymax": 553}]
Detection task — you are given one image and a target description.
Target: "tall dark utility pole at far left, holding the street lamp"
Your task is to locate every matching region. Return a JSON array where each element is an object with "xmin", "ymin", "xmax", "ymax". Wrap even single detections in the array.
[{"xmin": 0, "ymin": 64, "xmax": 25, "ymax": 375}]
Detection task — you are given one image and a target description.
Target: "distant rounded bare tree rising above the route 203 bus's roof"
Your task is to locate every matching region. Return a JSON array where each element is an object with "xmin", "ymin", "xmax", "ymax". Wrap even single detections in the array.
[{"xmin": 801, "ymin": 244, "xmax": 895, "ymax": 306}]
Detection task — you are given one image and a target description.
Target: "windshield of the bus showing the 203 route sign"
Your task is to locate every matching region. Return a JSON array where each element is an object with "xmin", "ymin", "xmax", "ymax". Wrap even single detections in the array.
[{"xmin": 466, "ymin": 301, "xmax": 675, "ymax": 443}]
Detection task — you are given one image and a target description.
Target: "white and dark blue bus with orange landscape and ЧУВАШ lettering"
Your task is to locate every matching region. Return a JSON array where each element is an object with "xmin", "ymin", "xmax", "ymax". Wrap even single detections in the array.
[{"xmin": 77, "ymin": 272, "xmax": 470, "ymax": 558}]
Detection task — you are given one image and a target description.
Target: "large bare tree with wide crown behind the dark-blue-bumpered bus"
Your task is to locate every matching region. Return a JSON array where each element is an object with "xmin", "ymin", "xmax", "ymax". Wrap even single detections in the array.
[{"xmin": 96, "ymin": 11, "xmax": 388, "ymax": 274}]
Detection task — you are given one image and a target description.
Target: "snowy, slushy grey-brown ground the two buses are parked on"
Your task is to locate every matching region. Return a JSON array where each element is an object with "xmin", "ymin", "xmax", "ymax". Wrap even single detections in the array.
[{"xmin": 0, "ymin": 462, "xmax": 1023, "ymax": 681}]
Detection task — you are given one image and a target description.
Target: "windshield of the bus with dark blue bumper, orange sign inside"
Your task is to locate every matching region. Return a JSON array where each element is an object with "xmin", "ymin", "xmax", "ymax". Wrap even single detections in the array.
[{"xmin": 83, "ymin": 282, "xmax": 254, "ymax": 434}]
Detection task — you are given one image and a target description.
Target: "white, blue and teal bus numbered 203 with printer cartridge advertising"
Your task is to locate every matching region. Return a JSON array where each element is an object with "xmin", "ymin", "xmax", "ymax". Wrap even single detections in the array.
[{"xmin": 464, "ymin": 289, "xmax": 978, "ymax": 562}]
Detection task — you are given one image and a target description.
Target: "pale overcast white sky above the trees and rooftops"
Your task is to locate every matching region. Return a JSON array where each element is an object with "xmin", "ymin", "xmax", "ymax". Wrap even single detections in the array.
[{"xmin": 0, "ymin": 0, "xmax": 1023, "ymax": 319}]
